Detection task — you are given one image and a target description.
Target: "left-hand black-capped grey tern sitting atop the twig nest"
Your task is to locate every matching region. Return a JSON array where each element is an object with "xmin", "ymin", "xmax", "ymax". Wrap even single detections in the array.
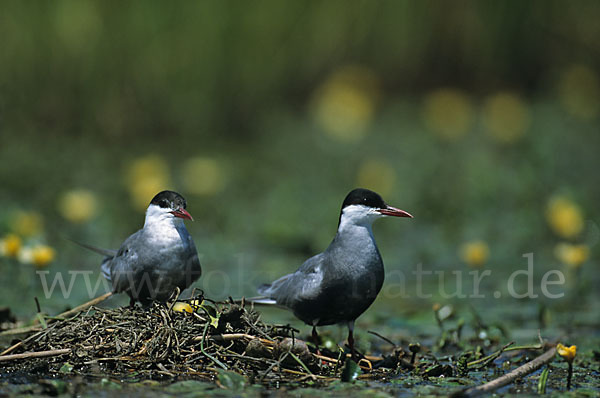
[{"xmin": 82, "ymin": 191, "xmax": 202, "ymax": 306}]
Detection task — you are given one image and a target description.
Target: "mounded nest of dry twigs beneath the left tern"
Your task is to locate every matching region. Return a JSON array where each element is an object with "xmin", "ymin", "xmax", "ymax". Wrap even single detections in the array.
[{"xmin": 3, "ymin": 297, "xmax": 398, "ymax": 384}]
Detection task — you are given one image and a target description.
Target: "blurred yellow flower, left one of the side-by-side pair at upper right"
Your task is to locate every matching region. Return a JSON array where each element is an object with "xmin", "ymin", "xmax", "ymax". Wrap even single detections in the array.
[{"xmin": 423, "ymin": 88, "xmax": 473, "ymax": 141}]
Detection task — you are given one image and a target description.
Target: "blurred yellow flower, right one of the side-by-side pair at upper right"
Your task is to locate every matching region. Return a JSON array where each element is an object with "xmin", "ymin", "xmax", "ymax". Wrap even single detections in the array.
[{"xmin": 483, "ymin": 92, "xmax": 530, "ymax": 144}]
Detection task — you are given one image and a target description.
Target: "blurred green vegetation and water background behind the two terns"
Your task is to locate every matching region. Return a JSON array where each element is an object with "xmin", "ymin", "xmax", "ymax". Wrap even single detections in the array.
[{"xmin": 0, "ymin": 1, "xmax": 600, "ymax": 342}]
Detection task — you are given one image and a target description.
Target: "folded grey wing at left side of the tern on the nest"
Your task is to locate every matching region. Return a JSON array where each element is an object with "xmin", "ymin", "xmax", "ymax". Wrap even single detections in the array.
[{"xmin": 102, "ymin": 230, "xmax": 143, "ymax": 293}]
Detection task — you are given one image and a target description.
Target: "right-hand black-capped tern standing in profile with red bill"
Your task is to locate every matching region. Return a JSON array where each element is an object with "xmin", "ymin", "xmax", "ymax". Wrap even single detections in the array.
[{"xmin": 252, "ymin": 188, "xmax": 412, "ymax": 360}]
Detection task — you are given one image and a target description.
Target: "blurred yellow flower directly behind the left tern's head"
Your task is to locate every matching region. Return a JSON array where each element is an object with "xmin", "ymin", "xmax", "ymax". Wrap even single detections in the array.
[{"xmin": 125, "ymin": 155, "xmax": 169, "ymax": 210}]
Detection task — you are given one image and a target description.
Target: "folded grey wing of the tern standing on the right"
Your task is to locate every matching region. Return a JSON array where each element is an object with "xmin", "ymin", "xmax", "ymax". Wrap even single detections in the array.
[{"xmin": 260, "ymin": 253, "xmax": 324, "ymax": 308}]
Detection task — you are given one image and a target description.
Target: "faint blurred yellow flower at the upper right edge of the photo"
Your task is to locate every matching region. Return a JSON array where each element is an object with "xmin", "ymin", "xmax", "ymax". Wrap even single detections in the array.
[{"xmin": 559, "ymin": 65, "xmax": 600, "ymax": 120}]
